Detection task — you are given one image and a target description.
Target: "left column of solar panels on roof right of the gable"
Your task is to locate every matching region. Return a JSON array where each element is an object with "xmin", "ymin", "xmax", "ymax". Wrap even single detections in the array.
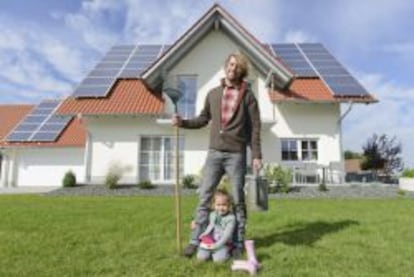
[{"xmin": 271, "ymin": 43, "xmax": 318, "ymax": 77}]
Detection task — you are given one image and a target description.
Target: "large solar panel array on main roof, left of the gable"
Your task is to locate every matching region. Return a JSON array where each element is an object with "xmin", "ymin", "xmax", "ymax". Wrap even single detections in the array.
[{"xmin": 72, "ymin": 44, "xmax": 169, "ymax": 97}]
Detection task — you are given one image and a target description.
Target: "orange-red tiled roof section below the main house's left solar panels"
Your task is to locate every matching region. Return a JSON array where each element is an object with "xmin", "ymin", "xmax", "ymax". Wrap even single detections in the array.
[{"xmin": 57, "ymin": 79, "xmax": 164, "ymax": 115}]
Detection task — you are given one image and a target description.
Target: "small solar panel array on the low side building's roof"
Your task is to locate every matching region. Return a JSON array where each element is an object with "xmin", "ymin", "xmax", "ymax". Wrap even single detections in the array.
[{"xmin": 6, "ymin": 100, "xmax": 72, "ymax": 142}]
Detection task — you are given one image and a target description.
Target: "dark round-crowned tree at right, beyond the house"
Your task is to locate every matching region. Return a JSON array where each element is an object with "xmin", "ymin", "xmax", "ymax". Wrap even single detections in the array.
[{"xmin": 361, "ymin": 134, "xmax": 403, "ymax": 176}]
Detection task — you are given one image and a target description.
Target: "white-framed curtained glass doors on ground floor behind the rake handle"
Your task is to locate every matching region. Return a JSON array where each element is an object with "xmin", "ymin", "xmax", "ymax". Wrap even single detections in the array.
[{"xmin": 139, "ymin": 136, "xmax": 184, "ymax": 182}]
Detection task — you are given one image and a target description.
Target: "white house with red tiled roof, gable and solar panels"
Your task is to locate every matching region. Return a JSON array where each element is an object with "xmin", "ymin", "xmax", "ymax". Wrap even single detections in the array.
[{"xmin": 0, "ymin": 4, "xmax": 377, "ymax": 187}]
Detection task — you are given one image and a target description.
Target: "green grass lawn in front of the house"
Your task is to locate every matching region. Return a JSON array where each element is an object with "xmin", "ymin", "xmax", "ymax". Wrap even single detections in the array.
[{"xmin": 0, "ymin": 195, "xmax": 414, "ymax": 277}]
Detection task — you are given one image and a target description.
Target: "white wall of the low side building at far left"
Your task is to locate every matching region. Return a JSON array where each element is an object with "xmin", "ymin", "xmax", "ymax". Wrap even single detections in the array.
[{"xmin": 9, "ymin": 147, "xmax": 85, "ymax": 187}]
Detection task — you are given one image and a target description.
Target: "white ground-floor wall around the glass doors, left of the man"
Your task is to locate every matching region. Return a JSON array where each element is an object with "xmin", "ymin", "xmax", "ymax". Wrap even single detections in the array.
[{"xmin": 86, "ymin": 117, "xmax": 213, "ymax": 184}]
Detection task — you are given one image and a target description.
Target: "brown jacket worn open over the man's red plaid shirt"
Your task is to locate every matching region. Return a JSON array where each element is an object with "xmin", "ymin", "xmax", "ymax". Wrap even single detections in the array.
[{"xmin": 180, "ymin": 82, "xmax": 262, "ymax": 159}]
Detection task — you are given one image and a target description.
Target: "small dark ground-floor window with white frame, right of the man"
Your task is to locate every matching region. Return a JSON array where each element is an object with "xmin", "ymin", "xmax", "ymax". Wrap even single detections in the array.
[{"xmin": 281, "ymin": 139, "xmax": 318, "ymax": 161}]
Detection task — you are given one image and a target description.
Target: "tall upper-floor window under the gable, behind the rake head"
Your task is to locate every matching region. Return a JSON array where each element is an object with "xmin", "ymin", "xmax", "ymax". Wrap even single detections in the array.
[{"xmin": 177, "ymin": 75, "xmax": 197, "ymax": 118}]
